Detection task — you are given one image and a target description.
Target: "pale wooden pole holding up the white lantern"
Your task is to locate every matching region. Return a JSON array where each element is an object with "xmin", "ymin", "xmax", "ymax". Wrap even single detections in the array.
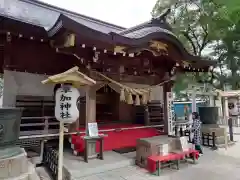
[{"xmin": 58, "ymin": 121, "xmax": 64, "ymax": 180}]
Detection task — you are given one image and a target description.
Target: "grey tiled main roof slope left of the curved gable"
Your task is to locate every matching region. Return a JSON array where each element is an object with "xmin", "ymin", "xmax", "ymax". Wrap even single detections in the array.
[{"xmin": 0, "ymin": 0, "xmax": 125, "ymax": 33}]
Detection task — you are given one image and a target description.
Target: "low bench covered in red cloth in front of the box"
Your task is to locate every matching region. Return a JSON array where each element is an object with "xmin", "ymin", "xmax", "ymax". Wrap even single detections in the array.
[{"xmin": 147, "ymin": 149, "xmax": 199, "ymax": 176}]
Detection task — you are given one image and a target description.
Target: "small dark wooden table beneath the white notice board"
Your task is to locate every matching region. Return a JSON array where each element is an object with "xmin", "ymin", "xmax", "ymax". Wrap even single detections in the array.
[{"xmin": 83, "ymin": 136, "xmax": 104, "ymax": 163}]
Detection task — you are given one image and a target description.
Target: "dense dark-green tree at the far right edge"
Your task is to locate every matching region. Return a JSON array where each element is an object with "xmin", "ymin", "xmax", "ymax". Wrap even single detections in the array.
[{"xmin": 208, "ymin": 0, "xmax": 240, "ymax": 89}]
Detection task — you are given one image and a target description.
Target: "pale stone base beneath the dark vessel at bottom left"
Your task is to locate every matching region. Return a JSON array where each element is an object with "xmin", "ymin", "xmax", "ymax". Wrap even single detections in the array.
[{"xmin": 0, "ymin": 147, "xmax": 39, "ymax": 180}]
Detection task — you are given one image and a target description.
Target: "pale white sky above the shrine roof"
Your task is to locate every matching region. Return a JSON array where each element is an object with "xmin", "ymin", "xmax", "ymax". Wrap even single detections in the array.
[{"xmin": 41, "ymin": 0, "xmax": 156, "ymax": 28}]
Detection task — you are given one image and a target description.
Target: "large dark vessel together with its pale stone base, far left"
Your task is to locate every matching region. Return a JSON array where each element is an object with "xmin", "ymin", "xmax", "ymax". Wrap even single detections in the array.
[{"xmin": 0, "ymin": 108, "xmax": 39, "ymax": 180}]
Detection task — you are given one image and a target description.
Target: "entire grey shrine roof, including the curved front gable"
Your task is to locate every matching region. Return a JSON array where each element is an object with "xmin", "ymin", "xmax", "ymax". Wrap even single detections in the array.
[{"xmin": 0, "ymin": 0, "xmax": 216, "ymax": 71}]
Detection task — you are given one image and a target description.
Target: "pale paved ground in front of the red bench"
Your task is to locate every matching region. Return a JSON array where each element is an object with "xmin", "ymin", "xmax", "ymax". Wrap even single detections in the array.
[{"xmin": 80, "ymin": 136, "xmax": 240, "ymax": 180}]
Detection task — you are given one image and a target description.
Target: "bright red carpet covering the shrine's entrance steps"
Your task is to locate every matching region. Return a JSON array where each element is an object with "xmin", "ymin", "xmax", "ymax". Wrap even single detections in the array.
[{"xmin": 72, "ymin": 124, "xmax": 159, "ymax": 152}]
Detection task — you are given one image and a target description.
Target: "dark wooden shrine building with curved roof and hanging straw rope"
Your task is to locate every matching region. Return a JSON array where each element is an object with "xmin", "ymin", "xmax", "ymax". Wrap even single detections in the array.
[{"xmin": 0, "ymin": 0, "xmax": 215, "ymax": 148}]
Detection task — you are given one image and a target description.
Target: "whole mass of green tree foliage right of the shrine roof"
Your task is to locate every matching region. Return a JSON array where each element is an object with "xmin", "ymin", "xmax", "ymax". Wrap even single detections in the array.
[{"xmin": 152, "ymin": 0, "xmax": 240, "ymax": 92}]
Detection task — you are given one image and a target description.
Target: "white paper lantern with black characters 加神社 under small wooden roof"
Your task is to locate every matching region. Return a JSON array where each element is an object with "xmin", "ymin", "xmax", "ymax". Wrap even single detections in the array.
[{"xmin": 55, "ymin": 85, "xmax": 80, "ymax": 123}]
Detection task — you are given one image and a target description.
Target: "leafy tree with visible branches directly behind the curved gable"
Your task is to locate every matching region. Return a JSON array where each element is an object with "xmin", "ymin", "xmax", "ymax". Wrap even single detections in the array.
[{"xmin": 152, "ymin": 0, "xmax": 214, "ymax": 95}]
